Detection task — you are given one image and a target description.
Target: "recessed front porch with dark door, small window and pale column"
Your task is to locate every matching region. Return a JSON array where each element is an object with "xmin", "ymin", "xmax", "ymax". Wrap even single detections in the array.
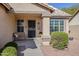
[{"xmin": 14, "ymin": 13, "xmax": 50, "ymax": 44}]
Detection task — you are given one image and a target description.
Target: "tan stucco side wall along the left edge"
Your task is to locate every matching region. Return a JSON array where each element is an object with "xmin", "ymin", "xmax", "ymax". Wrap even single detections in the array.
[{"xmin": 0, "ymin": 4, "xmax": 15, "ymax": 48}]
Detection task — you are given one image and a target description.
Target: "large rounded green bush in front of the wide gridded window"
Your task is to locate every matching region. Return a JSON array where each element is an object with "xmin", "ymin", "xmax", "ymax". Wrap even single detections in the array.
[{"xmin": 50, "ymin": 32, "xmax": 68, "ymax": 49}]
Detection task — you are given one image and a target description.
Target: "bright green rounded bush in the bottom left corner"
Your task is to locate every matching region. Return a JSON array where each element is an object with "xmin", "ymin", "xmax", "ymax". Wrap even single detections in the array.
[{"xmin": 1, "ymin": 47, "xmax": 17, "ymax": 56}]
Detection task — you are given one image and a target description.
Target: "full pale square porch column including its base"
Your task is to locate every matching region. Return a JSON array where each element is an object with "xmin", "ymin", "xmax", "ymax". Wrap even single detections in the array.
[{"xmin": 42, "ymin": 17, "xmax": 50, "ymax": 45}]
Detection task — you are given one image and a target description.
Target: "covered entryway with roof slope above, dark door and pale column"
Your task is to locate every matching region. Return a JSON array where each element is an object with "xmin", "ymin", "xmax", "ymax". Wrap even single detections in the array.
[{"xmin": 10, "ymin": 3, "xmax": 53, "ymax": 44}]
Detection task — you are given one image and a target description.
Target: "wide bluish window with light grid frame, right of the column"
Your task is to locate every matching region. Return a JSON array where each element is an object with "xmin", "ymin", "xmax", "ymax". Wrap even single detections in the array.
[{"xmin": 50, "ymin": 19, "xmax": 65, "ymax": 32}]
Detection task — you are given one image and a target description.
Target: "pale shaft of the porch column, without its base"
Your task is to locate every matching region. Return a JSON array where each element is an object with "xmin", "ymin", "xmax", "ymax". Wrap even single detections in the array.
[{"xmin": 42, "ymin": 17, "xmax": 50, "ymax": 36}]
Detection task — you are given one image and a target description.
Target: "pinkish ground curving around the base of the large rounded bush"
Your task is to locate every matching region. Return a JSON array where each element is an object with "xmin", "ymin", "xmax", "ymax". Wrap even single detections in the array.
[{"xmin": 42, "ymin": 39, "xmax": 79, "ymax": 56}]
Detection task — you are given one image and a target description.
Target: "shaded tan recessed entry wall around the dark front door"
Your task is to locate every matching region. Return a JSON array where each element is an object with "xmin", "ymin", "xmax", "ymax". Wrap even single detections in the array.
[{"xmin": 15, "ymin": 13, "xmax": 42, "ymax": 39}]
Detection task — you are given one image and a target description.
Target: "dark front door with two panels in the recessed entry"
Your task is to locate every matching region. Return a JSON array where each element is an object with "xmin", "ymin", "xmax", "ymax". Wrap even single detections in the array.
[{"xmin": 28, "ymin": 20, "xmax": 36, "ymax": 38}]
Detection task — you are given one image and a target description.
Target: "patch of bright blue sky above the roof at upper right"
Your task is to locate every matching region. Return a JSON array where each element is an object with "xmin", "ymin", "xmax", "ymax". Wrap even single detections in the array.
[{"xmin": 49, "ymin": 3, "xmax": 75, "ymax": 8}]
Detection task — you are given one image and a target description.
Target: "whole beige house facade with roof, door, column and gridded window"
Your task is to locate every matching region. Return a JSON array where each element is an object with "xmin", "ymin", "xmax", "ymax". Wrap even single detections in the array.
[{"xmin": 0, "ymin": 3, "xmax": 71, "ymax": 48}]
